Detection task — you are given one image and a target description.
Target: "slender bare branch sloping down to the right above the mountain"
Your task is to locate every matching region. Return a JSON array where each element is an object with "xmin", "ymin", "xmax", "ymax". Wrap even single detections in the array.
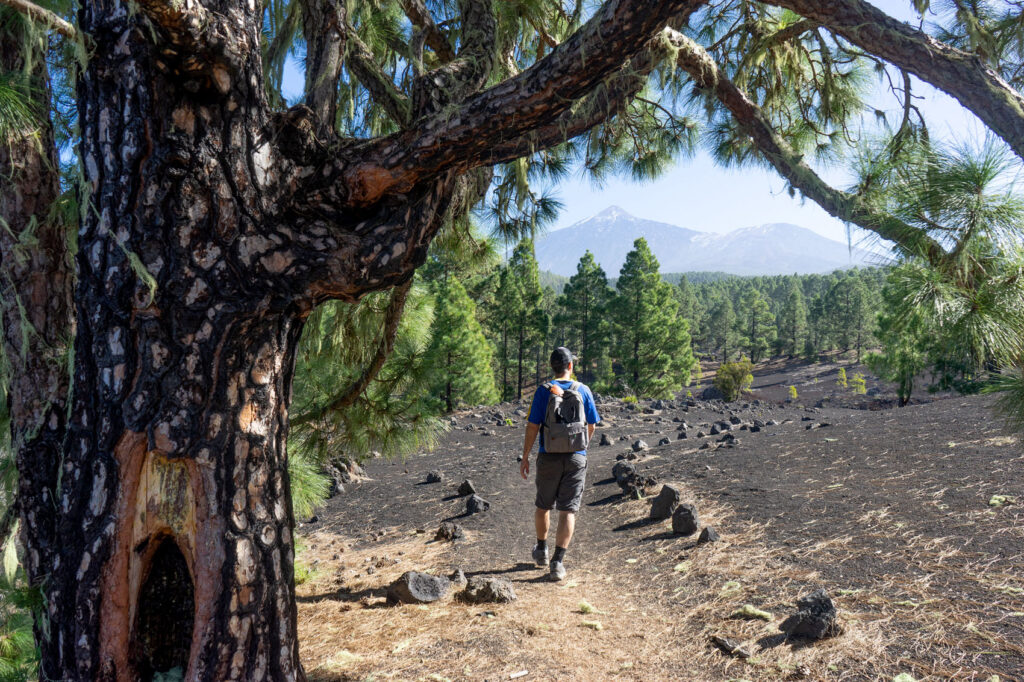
[{"xmin": 670, "ymin": 31, "xmax": 946, "ymax": 265}]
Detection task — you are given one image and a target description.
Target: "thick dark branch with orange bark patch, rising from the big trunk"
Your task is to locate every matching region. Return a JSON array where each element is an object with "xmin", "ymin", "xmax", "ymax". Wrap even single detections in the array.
[{"xmin": 331, "ymin": 0, "xmax": 707, "ymax": 206}]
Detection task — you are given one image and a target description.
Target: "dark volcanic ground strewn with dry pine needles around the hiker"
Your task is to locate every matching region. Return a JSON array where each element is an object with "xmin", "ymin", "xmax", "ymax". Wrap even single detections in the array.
[{"xmin": 298, "ymin": 366, "xmax": 1024, "ymax": 681}]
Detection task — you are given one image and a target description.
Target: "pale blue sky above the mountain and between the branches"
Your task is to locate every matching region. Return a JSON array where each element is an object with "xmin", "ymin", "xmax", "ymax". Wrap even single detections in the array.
[{"xmin": 284, "ymin": 0, "xmax": 985, "ymax": 244}]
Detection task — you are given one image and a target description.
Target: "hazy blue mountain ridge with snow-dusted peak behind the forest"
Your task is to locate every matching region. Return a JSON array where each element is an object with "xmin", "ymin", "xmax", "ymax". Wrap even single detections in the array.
[{"xmin": 536, "ymin": 206, "xmax": 879, "ymax": 278}]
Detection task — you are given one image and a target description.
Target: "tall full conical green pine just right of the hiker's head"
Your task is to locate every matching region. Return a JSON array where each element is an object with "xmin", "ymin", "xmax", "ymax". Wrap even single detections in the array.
[{"xmin": 610, "ymin": 238, "xmax": 695, "ymax": 397}]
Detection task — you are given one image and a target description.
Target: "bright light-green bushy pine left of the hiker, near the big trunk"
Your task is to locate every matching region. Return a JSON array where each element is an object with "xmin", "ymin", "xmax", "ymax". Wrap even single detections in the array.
[{"xmin": 424, "ymin": 276, "xmax": 498, "ymax": 412}]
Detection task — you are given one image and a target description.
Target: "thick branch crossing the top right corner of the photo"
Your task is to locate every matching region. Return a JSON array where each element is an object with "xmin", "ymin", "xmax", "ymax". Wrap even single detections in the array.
[{"xmin": 767, "ymin": 0, "xmax": 1024, "ymax": 159}]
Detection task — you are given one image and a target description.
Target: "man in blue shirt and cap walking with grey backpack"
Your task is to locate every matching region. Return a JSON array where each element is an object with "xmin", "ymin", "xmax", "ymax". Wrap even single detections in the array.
[{"xmin": 519, "ymin": 346, "xmax": 601, "ymax": 581}]
